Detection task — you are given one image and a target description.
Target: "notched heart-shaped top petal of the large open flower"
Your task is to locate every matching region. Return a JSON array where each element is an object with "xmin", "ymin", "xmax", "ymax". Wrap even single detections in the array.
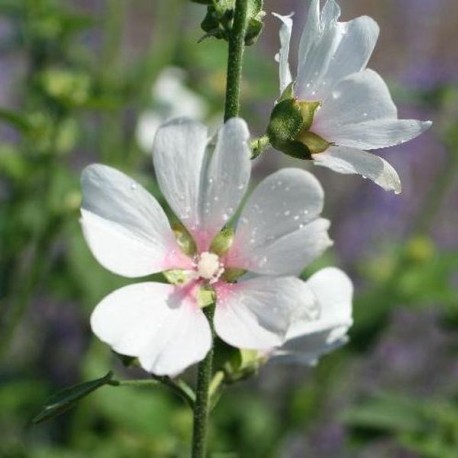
[{"xmin": 153, "ymin": 118, "xmax": 251, "ymax": 251}]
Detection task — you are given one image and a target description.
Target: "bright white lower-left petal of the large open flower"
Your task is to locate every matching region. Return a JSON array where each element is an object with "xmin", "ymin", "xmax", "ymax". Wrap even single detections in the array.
[{"xmin": 91, "ymin": 282, "xmax": 211, "ymax": 376}]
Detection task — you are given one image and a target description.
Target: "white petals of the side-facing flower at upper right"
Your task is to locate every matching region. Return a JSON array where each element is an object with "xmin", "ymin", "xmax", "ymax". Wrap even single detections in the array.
[{"xmin": 276, "ymin": 0, "xmax": 431, "ymax": 193}]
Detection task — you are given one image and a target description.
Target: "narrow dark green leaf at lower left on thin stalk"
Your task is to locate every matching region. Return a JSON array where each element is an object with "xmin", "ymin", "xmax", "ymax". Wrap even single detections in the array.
[{"xmin": 32, "ymin": 371, "xmax": 113, "ymax": 424}]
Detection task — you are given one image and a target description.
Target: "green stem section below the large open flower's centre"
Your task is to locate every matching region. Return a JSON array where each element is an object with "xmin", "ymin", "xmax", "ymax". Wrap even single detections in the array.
[{"xmin": 192, "ymin": 305, "xmax": 215, "ymax": 458}]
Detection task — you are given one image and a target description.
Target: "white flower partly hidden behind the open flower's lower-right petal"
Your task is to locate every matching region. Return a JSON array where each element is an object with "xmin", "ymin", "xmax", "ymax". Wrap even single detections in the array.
[{"xmin": 271, "ymin": 267, "xmax": 353, "ymax": 365}]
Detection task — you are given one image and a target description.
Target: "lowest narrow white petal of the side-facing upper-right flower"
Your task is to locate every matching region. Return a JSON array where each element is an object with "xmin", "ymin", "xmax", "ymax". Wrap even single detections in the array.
[{"xmin": 313, "ymin": 146, "xmax": 401, "ymax": 194}]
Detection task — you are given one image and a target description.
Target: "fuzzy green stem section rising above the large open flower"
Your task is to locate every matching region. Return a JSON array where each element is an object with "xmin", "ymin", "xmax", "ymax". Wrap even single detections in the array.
[{"xmin": 224, "ymin": 0, "xmax": 248, "ymax": 121}]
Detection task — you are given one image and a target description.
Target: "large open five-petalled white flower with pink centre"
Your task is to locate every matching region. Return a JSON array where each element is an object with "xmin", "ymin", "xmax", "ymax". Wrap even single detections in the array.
[{"xmin": 81, "ymin": 118, "xmax": 330, "ymax": 375}]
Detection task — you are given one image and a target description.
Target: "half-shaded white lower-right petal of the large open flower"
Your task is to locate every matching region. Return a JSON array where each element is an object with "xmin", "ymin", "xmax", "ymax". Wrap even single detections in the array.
[{"xmin": 214, "ymin": 277, "xmax": 308, "ymax": 350}]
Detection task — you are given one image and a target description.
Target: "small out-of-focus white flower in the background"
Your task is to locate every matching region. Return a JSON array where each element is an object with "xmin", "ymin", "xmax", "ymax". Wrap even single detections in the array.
[{"xmin": 137, "ymin": 67, "xmax": 208, "ymax": 154}]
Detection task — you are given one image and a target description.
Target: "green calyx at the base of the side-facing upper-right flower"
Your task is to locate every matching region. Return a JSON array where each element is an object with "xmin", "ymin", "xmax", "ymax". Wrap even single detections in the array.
[{"xmin": 267, "ymin": 94, "xmax": 331, "ymax": 159}]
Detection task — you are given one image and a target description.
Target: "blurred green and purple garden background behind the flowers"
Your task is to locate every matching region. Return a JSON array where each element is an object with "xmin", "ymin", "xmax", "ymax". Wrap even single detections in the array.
[{"xmin": 0, "ymin": 0, "xmax": 458, "ymax": 458}]
